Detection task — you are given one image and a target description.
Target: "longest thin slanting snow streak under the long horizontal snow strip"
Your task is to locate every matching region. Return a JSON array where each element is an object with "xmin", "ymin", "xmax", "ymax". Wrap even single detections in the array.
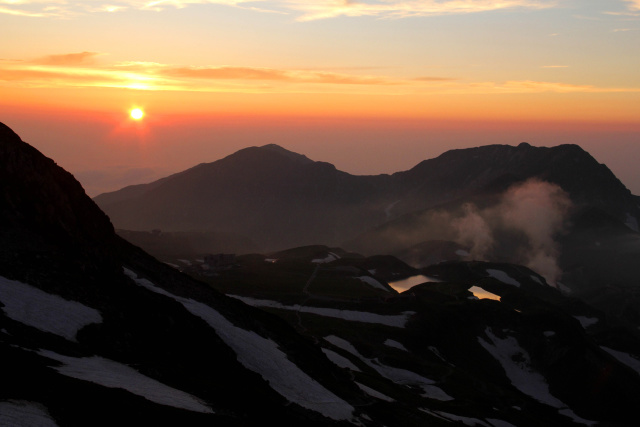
[{"xmin": 324, "ymin": 335, "xmax": 453, "ymax": 401}]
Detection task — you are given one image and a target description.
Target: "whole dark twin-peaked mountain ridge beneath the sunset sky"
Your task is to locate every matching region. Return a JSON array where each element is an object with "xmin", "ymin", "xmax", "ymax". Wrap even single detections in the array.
[{"xmin": 95, "ymin": 143, "xmax": 640, "ymax": 250}]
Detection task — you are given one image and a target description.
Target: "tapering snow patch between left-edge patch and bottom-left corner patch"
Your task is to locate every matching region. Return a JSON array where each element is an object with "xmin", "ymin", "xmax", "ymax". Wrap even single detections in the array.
[{"xmin": 38, "ymin": 350, "xmax": 213, "ymax": 414}]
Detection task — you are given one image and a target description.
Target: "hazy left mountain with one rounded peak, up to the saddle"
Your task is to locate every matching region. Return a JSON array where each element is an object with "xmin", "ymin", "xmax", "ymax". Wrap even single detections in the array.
[{"xmin": 95, "ymin": 145, "xmax": 384, "ymax": 249}]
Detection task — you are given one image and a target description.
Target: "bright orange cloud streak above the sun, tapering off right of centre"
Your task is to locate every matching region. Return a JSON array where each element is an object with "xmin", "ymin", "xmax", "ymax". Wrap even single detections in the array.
[{"xmin": 0, "ymin": 52, "xmax": 409, "ymax": 91}]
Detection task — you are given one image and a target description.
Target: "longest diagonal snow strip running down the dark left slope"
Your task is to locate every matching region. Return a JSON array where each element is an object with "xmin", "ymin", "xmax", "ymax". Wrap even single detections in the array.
[{"xmin": 125, "ymin": 269, "xmax": 354, "ymax": 420}]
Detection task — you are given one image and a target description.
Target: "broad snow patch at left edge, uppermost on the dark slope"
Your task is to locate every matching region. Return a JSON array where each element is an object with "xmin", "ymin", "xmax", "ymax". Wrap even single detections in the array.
[{"xmin": 0, "ymin": 276, "xmax": 102, "ymax": 341}]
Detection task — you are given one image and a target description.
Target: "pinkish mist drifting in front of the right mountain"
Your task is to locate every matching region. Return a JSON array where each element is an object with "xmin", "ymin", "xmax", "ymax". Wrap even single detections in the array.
[{"xmin": 378, "ymin": 179, "xmax": 572, "ymax": 285}]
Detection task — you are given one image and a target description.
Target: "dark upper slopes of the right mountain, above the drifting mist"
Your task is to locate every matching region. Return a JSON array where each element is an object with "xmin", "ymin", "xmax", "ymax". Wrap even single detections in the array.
[{"xmin": 394, "ymin": 143, "xmax": 640, "ymax": 222}]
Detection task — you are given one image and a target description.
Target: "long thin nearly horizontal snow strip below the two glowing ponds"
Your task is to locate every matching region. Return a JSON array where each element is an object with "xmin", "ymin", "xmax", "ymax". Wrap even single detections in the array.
[{"xmin": 227, "ymin": 295, "xmax": 415, "ymax": 328}]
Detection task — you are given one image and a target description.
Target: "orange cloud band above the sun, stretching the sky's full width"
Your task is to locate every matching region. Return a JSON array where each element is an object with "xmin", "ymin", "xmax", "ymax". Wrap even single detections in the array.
[{"xmin": 0, "ymin": 52, "xmax": 640, "ymax": 95}]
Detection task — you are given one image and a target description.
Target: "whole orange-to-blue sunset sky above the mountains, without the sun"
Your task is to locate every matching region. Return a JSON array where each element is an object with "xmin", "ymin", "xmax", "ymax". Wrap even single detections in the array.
[{"xmin": 0, "ymin": 0, "xmax": 640, "ymax": 196}]
